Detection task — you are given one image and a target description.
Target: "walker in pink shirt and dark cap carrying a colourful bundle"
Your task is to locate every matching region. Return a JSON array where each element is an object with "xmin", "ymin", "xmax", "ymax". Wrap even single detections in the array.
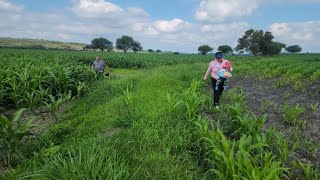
[{"xmin": 203, "ymin": 52, "xmax": 233, "ymax": 109}]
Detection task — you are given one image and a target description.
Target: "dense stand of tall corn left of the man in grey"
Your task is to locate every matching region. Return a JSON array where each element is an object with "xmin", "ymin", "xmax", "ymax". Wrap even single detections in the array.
[{"xmin": 0, "ymin": 50, "xmax": 95, "ymax": 109}]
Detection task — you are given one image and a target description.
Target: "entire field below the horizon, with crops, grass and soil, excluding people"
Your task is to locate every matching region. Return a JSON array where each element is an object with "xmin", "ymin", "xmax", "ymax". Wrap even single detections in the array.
[{"xmin": 0, "ymin": 49, "xmax": 320, "ymax": 180}]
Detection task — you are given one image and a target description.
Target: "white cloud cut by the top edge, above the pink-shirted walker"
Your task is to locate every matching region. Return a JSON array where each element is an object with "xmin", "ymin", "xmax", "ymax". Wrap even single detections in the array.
[{"xmin": 195, "ymin": 0, "xmax": 259, "ymax": 22}]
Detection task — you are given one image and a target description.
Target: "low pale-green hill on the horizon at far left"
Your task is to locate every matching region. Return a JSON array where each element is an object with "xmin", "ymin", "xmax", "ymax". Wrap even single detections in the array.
[{"xmin": 0, "ymin": 37, "xmax": 87, "ymax": 50}]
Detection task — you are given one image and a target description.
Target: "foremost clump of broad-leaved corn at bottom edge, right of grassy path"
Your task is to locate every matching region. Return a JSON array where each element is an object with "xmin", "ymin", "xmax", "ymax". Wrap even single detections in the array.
[{"xmin": 204, "ymin": 128, "xmax": 287, "ymax": 179}]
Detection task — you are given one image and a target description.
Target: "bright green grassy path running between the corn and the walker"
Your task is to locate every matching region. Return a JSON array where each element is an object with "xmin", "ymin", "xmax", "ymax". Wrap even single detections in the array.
[{"xmin": 5, "ymin": 64, "xmax": 209, "ymax": 179}]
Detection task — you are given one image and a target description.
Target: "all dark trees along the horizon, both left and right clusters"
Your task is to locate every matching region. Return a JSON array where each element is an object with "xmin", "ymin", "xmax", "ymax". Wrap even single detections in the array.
[{"xmin": 83, "ymin": 29, "xmax": 302, "ymax": 55}]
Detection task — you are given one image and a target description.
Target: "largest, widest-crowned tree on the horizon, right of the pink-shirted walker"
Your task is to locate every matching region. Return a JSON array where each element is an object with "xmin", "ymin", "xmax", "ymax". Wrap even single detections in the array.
[{"xmin": 235, "ymin": 29, "xmax": 286, "ymax": 55}]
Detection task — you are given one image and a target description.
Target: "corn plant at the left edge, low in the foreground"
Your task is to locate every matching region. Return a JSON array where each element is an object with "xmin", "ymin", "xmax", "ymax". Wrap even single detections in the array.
[{"xmin": 0, "ymin": 108, "xmax": 34, "ymax": 167}]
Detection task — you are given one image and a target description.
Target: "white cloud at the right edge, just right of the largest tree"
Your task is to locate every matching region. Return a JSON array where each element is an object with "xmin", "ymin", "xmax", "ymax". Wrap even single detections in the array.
[{"xmin": 269, "ymin": 21, "xmax": 320, "ymax": 52}]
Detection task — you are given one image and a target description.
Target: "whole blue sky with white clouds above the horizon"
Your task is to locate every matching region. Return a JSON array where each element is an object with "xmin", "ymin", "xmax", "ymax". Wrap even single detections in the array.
[{"xmin": 0, "ymin": 0, "xmax": 320, "ymax": 53}]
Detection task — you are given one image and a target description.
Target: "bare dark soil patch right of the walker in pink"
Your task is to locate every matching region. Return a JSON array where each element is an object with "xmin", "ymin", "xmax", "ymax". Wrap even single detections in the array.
[{"xmin": 225, "ymin": 76, "xmax": 320, "ymax": 162}]
